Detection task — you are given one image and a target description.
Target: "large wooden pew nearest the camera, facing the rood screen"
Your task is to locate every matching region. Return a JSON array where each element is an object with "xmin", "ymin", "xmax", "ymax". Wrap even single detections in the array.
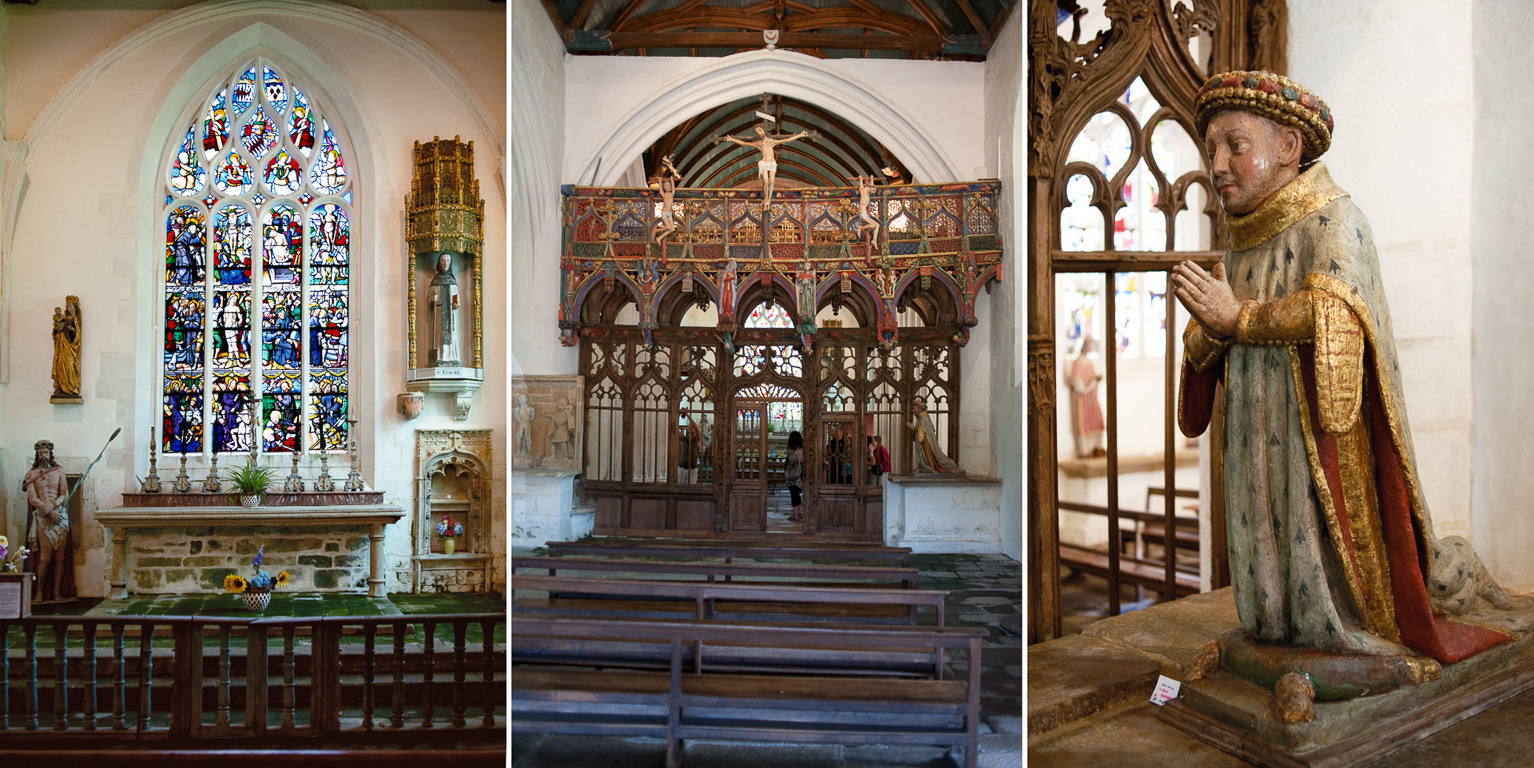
[{"xmin": 509, "ymin": 616, "xmax": 985, "ymax": 768}]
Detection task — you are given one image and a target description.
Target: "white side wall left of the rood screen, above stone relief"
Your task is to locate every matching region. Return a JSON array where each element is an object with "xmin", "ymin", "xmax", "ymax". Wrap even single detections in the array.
[{"xmin": 509, "ymin": 3, "xmax": 576, "ymax": 376}]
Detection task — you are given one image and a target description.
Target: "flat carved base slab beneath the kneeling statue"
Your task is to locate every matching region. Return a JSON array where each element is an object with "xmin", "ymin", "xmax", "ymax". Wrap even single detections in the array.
[{"xmin": 1160, "ymin": 596, "xmax": 1534, "ymax": 768}]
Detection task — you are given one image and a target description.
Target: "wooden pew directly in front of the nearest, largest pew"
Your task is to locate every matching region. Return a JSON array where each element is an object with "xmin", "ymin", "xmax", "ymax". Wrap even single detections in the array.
[{"xmin": 511, "ymin": 575, "xmax": 948, "ymax": 627}]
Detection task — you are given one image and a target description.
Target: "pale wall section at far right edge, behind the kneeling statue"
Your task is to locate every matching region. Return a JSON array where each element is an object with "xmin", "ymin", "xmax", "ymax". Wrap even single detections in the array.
[{"xmin": 1470, "ymin": 0, "xmax": 1534, "ymax": 592}]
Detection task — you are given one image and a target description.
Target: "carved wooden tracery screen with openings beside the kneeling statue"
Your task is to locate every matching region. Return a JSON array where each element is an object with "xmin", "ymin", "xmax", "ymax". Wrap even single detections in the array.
[{"xmin": 1026, "ymin": 0, "xmax": 1287, "ymax": 642}]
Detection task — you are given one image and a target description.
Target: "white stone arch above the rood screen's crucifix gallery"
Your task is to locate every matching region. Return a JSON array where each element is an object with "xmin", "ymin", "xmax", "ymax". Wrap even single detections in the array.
[{"xmin": 572, "ymin": 51, "xmax": 966, "ymax": 187}]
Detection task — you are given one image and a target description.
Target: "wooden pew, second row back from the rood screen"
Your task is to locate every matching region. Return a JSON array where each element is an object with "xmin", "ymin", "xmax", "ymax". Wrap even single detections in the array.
[{"xmin": 511, "ymin": 556, "xmax": 920, "ymax": 589}]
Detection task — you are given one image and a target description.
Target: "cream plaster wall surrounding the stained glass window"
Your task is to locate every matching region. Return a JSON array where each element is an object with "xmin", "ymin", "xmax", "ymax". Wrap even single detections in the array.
[{"xmin": 0, "ymin": 0, "xmax": 506, "ymax": 595}]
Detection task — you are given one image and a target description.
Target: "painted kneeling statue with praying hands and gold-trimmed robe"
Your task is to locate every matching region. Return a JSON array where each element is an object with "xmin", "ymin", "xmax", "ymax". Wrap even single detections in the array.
[{"xmin": 1172, "ymin": 72, "xmax": 1509, "ymax": 662}]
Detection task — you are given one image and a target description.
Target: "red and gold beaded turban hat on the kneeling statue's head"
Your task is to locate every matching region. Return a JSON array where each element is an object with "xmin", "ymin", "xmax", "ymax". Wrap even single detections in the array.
[{"xmin": 1193, "ymin": 72, "xmax": 1332, "ymax": 162}]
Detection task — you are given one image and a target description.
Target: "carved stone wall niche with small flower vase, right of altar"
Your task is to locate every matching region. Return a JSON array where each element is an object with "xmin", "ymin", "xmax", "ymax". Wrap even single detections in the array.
[{"xmin": 411, "ymin": 429, "xmax": 492, "ymax": 593}]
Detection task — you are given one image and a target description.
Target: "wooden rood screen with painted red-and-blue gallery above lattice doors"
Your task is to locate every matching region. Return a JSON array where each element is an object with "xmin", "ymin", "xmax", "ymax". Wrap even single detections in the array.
[{"xmin": 560, "ymin": 181, "xmax": 1002, "ymax": 541}]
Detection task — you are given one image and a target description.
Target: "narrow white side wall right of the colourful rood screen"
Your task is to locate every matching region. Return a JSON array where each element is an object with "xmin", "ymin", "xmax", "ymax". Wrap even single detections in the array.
[{"xmin": 965, "ymin": 12, "xmax": 1028, "ymax": 561}]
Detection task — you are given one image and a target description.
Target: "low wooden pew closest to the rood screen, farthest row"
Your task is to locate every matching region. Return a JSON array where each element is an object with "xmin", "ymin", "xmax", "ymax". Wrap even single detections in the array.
[{"xmin": 545, "ymin": 538, "xmax": 911, "ymax": 567}]
